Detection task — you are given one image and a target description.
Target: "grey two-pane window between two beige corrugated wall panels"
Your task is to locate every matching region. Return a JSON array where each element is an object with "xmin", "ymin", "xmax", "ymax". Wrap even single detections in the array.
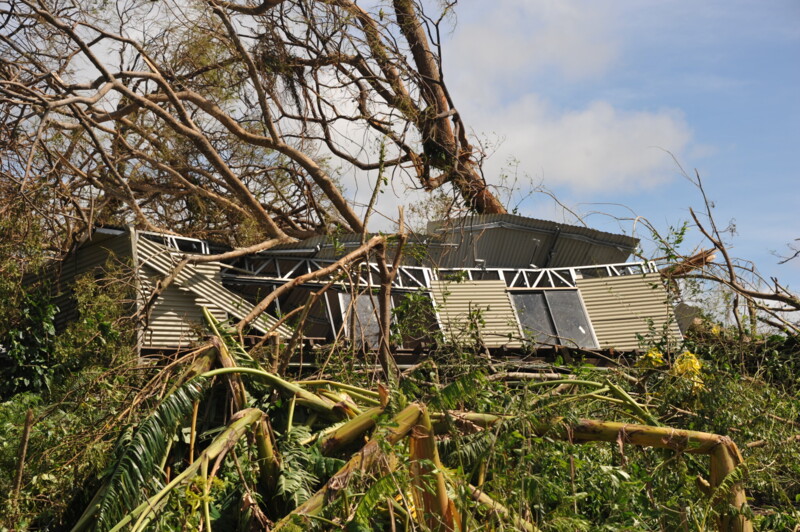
[{"xmin": 511, "ymin": 290, "xmax": 597, "ymax": 348}]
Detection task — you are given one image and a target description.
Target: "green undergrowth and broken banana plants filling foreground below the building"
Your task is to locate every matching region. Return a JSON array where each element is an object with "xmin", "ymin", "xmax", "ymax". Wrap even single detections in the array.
[{"xmin": 0, "ymin": 300, "xmax": 800, "ymax": 530}]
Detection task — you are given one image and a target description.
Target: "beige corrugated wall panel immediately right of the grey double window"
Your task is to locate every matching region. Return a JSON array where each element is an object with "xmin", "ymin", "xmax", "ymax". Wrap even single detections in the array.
[{"xmin": 578, "ymin": 273, "xmax": 681, "ymax": 351}]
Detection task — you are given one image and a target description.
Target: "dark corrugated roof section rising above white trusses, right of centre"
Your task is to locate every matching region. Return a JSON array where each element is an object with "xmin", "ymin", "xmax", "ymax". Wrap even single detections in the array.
[{"xmin": 428, "ymin": 214, "xmax": 638, "ymax": 268}]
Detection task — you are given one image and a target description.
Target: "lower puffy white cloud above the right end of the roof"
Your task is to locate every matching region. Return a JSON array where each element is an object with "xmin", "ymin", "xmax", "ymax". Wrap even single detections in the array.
[{"xmin": 478, "ymin": 95, "xmax": 691, "ymax": 192}]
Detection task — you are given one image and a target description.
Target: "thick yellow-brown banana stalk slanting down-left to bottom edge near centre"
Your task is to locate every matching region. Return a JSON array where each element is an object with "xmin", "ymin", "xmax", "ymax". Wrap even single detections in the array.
[{"xmin": 272, "ymin": 403, "xmax": 422, "ymax": 532}]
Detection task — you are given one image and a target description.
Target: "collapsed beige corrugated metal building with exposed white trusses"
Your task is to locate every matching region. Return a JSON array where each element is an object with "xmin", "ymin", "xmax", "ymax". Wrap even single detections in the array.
[{"xmin": 40, "ymin": 215, "xmax": 680, "ymax": 356}]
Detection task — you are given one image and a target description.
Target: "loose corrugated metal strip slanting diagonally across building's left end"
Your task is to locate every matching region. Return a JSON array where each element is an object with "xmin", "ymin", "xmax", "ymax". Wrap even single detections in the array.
[{"xmin": 137, "ymin": 238, "xmax": 292, "ymax": 337}]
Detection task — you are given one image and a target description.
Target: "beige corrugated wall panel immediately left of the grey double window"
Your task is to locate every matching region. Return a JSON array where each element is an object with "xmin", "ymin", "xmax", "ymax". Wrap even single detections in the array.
[{"xmin": 431, "ymin": 281, "xmax": 522, "ymax": 347}]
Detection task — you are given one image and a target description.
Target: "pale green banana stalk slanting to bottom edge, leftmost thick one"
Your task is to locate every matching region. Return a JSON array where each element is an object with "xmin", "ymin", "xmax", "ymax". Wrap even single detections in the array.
[{"xmin": 110, "ymin": 408, "xmax": 264, "ymax": 532}]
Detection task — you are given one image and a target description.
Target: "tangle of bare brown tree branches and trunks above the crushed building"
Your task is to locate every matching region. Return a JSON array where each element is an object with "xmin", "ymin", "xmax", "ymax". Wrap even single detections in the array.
[{"xmin": 0, "ymin": 0, "xmax": 504, "ymax": 254}]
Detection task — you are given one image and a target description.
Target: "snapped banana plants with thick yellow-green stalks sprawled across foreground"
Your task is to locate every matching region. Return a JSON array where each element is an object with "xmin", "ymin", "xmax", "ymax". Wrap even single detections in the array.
[{"xmin": 61, "ymin": 314, "xmax": 752, "ymax": 532}]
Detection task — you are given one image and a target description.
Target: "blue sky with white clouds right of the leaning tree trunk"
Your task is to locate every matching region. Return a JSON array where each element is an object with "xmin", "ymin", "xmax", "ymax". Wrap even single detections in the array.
[{"xmin": 412, "ymin": 0, "xmax": 800, "ymax": 290}]
